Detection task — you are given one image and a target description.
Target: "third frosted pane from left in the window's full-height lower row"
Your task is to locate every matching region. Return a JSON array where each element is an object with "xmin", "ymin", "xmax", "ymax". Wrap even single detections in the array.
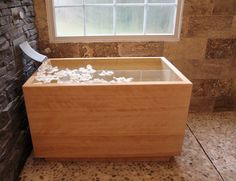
[{"xmin": 116, "ymin": 6, "xmax": 144, "ymax": 34}]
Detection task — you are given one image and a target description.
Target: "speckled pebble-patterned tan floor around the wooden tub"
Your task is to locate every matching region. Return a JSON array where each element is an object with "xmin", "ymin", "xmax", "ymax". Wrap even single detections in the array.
[{"xmin": 20, "ymin": 112, "xmax": 236, "ymax": 181}]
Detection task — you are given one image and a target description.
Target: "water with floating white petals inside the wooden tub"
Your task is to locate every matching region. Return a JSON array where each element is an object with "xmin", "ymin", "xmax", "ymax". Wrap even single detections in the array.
[{"xmin": 34, "ymin": 62, "xmax": 171, "ymax": 84}]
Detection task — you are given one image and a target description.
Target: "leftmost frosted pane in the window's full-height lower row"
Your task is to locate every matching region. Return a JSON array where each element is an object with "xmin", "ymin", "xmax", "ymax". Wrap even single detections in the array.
[{"xmin": 55, "ymin": 7, "xmax": 84, "ymax": 36}]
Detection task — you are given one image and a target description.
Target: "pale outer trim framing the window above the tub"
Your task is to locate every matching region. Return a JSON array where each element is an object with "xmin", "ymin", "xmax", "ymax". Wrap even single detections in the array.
[{"xmin": 46, "ymin": 0, "xmax": 184, "ymax": 43}]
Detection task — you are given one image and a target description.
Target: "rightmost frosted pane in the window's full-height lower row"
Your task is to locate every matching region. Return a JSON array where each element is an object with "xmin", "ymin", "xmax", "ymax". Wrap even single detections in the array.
[{"xmin": 146, "ymin": 6, "xmax": 175, "ymax": 34}]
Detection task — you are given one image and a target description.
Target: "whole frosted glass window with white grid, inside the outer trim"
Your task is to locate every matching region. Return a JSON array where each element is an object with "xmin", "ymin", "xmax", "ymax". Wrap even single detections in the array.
[{"xmin": 49, "ymin": 0, "xmax": 182, "ymax": 41}]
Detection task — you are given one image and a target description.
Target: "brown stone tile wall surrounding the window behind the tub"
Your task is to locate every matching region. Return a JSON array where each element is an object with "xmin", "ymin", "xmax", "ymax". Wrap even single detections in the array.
[{"xmin": 34, "ymin": 0, "xmax": 236, "ymax": 112}]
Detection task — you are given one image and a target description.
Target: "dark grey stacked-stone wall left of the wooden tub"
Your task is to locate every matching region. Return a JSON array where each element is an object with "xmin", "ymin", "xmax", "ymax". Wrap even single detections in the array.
[{"xmin": 0, "ymin": 0, "xmax": 37, "ymax": 181}]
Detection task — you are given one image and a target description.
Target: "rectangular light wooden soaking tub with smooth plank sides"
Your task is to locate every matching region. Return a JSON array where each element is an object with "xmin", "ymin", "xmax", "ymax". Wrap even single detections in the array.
[{"xmin": 23, "ymin": 57, "xmax": 192, "ymax": 159}]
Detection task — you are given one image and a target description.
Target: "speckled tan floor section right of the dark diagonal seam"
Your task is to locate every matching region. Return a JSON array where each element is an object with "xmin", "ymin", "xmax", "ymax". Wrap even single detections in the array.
[{"xmin": 188, "ymin": 112, "xmax": 236, "ymax": 181}]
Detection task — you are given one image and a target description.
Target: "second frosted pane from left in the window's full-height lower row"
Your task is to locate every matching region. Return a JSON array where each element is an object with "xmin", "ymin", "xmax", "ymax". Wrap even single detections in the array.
[{"xmin": 86, "ymin": 6, "xmax": 113, "ymax": 35}]
